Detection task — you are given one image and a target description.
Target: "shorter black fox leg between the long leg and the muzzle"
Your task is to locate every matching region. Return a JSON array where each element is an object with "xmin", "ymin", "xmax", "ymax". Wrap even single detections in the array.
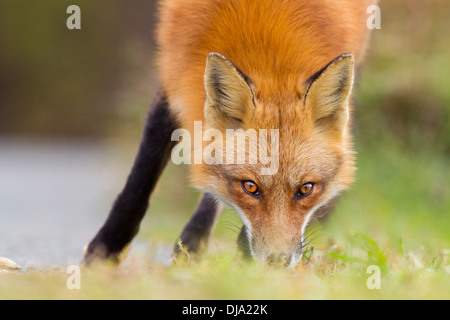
[{"xmin": 174, "ymin": 193, "xmax": 224, "ymax": 255}]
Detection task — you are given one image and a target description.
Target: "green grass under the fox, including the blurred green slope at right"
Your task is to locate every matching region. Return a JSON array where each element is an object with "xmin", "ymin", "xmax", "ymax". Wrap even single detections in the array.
[{"xmin": 0, "ymin": 144, "xmax": 450, "ymax": 299}]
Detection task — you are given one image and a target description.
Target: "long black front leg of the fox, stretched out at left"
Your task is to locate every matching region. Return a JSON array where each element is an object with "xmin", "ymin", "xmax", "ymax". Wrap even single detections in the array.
[{"xmin": 85, "ymin": 93, "xmax": 176, "ymax": 263}]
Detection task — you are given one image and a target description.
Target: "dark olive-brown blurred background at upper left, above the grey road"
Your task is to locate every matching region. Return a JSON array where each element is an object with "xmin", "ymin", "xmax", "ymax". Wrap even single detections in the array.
[{"xmin": 0, "ymin": 0, "xmax": 160, "ymax": 138}]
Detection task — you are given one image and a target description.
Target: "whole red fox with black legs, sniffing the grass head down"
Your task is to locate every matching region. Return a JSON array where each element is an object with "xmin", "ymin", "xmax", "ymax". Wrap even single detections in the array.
[{"xmin": 85, "ymin": 0, "xmax": 375, "ymax": 267}]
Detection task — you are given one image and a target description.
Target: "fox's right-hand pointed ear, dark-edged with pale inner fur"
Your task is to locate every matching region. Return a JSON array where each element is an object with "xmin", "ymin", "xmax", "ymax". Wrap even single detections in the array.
[{"xmin": 304, "ymin": 54, "xmax": 354, "ymax": 132}]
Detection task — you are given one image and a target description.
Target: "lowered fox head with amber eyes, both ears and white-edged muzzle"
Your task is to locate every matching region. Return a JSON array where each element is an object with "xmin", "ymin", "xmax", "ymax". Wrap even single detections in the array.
[{"xmin": 196, "ymin": 53, "xmax": 354, "ymax": 267}]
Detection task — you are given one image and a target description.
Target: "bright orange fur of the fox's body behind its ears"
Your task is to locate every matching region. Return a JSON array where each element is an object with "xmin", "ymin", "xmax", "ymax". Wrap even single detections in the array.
[{"xmin": 158, "ymin": 0, "xmax": 374, "ymax": 127}]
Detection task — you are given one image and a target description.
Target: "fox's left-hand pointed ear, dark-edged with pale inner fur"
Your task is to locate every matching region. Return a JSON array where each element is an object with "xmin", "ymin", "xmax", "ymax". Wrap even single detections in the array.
[{"xmin": 205, "ymin": 53, "xmax": 254, "ymax": 129}]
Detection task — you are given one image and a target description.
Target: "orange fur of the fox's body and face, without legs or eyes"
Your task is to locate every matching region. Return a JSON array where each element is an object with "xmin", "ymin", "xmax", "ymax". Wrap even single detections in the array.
[{"xmin": 158, "ymin": 0, "xmax": 374, "ymax": 264}]
